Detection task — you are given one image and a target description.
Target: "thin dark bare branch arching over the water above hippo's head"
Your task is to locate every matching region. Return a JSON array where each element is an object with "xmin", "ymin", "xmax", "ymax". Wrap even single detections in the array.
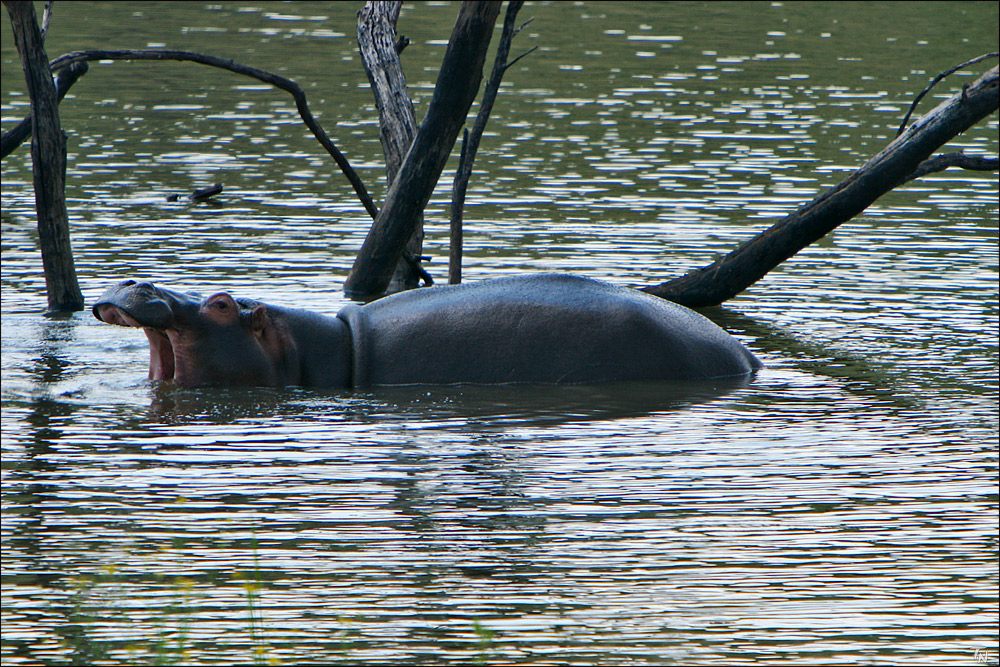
[{"xmin": 49, "ymin": 49, "xmax": 378, "ymax": 218}]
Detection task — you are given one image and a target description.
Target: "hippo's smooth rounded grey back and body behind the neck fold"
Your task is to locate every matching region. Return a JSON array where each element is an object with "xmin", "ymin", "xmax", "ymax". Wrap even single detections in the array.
[{"xmin": 339, "ymin": 273, "xmax": 760, "ymax": 387}]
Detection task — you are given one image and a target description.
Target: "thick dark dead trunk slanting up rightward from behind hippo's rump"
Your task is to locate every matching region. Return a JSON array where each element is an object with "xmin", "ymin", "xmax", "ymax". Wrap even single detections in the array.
[{"xmin": 642, "ymin": 62, "xmax": 1000, "ymax": 307}]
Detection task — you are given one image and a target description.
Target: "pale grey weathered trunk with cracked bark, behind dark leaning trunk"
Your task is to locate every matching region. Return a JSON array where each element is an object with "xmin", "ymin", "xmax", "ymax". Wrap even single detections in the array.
[{"xmin": 358, "ymin": 0, "xmax": 424, "ymax": 292}]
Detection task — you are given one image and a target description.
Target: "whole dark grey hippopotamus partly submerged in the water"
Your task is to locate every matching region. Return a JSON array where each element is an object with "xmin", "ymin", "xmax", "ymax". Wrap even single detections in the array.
[{"xmin": 93, "ymin": 273, "xmax": 761, "ymax": 389}]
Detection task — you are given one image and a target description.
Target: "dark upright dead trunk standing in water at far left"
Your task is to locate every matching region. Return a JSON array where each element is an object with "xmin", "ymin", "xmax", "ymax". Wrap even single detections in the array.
[{"xmin": 4, "ymin": 0, "xmax": 83, "ymax": 311}]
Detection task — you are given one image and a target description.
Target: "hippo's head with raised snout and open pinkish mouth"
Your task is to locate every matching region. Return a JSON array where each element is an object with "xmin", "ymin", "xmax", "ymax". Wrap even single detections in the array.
[{"xmin": 93, "ymin": 280, "xmax": 299, "ymax": 387}]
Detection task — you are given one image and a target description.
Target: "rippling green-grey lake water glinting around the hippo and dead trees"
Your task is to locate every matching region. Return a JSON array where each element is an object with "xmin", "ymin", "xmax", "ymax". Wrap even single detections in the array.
[{"xmin": 0, "ymin": 2, "xmax": 1000, "ymax": 666}]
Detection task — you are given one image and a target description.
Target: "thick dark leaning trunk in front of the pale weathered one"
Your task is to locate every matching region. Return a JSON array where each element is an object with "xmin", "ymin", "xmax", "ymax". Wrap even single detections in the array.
[{"xmin": 344, "ymin": 0, "xmax": 501, "ymax": 301}]
